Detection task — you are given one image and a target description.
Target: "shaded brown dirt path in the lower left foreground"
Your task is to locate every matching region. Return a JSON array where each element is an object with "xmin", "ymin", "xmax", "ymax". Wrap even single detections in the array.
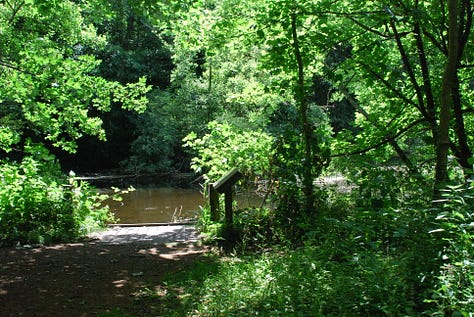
[{"xmin": 0, "ymin": 226, "xmax": 205, "ymax": 317}]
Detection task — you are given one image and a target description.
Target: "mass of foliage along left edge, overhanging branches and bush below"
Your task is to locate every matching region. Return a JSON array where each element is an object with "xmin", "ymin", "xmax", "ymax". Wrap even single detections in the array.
[{"xmin": 0, "ymin": 0, "xmax": 150, "ymax": 244}]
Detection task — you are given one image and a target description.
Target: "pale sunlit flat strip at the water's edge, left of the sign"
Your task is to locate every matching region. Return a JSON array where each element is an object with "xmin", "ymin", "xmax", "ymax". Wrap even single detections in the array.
[{"xmin": 93, "ymin": 224, "xmax": 199, "ymax": 244}]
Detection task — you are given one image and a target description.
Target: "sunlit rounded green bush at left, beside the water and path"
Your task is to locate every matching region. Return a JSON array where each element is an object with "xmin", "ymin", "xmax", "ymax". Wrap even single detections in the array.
[{"xmin": 0, "ymin": 156, "xmax": 112, "ymax": 244}]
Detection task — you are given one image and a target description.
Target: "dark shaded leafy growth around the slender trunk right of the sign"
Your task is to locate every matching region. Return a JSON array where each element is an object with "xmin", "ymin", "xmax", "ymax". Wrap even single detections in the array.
[{"xmin": 268, "ymin": 104, "xmax": 331, "ymax": 243}]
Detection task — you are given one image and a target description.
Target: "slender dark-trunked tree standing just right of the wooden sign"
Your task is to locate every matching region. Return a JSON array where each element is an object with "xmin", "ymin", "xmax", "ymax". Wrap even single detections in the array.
[{"xmin": 257, "ymin": 1, "xmax": 329, "ymax": 216}]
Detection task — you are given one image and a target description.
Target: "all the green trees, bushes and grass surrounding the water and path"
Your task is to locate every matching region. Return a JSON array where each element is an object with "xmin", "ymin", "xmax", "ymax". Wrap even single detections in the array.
[{"xmin": 0, "ymin": 0, "xmax": 474, "ymax": 316}]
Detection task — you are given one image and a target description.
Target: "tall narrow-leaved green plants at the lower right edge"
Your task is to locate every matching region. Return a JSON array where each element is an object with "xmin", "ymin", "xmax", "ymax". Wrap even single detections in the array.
[{"xmin": 427, "ymin": 183, "xmax": 474, "ymax": 316}]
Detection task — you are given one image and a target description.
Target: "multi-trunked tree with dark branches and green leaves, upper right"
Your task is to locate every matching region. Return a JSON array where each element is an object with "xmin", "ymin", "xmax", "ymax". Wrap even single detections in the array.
[{"xmin": 313, "ymin": 1, "xmax": 473, "ymax": 188}]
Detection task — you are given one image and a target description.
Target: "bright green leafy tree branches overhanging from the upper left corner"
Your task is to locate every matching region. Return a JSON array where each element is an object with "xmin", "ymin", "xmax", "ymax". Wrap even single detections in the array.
[{"xmin": 0, "ymin": 0, "xmax": 149, "ymax": 153}]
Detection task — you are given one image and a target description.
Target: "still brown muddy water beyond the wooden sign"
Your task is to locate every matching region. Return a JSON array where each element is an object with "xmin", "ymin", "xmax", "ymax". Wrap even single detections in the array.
[{"xmin": 107, "ymin": 187, "xmax": 261, "ymax": 224}]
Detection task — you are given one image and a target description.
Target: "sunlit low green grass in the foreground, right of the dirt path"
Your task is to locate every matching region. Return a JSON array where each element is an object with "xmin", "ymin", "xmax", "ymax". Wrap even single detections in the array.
[{"xmin": 115, "ymin": 246, "xmax": 422, "ymax": 317}]
